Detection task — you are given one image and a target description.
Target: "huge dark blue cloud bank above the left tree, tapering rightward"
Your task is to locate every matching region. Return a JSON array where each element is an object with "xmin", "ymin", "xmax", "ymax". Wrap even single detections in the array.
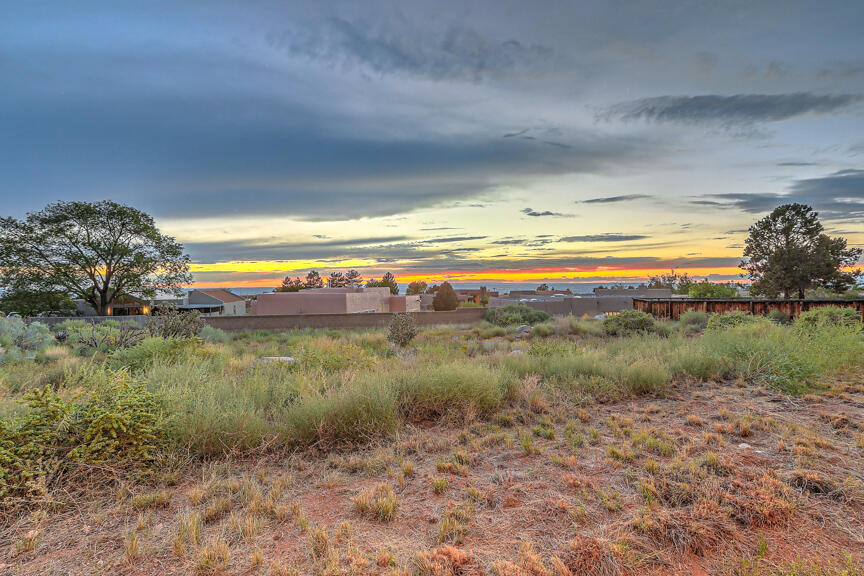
[{"xmin": 0, "ymin": 55, "xmax": 644, "ymax": 220}]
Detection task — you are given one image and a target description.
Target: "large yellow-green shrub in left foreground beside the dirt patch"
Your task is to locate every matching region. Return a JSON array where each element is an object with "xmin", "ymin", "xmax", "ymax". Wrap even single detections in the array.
[{"xmin": 0, "ymin": 367, "xmax": 164, "ymax": 497}]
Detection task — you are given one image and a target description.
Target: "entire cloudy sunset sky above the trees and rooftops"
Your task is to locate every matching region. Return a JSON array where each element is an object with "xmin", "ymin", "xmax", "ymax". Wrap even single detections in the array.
[{"xmin": 0, "ymin": 0, "xmax": 864, "ymax": 286}]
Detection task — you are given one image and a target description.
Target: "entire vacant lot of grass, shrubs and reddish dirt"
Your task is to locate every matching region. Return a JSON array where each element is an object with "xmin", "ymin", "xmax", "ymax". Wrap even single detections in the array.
[{"xmin": 0, "ymin": 318, "xmax": 864, "ymax": 576}]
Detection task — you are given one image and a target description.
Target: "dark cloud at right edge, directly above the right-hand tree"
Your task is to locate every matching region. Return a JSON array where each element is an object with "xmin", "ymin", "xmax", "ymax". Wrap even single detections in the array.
[{"xmin": 691, "ymin": 170, "xmax": 864, "ymax": 221}]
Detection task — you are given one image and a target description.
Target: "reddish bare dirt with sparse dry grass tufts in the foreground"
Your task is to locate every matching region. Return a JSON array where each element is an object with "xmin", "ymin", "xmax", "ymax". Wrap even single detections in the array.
[{"xmin": 0, "ymin": 381, "xmax": 864, "ymax": 576}]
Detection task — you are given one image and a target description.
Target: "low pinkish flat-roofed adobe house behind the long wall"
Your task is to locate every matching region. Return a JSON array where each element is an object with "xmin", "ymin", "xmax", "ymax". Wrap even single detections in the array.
[{"xmin": 251, "ymin": 286, "xmax": 420, "ymax": 316}]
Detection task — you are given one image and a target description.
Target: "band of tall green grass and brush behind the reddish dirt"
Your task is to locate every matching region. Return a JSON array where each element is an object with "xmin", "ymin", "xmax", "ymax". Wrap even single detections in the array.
[{"xmin": 0, "ymin": 319, "xmax": 864, "ymax": 464}]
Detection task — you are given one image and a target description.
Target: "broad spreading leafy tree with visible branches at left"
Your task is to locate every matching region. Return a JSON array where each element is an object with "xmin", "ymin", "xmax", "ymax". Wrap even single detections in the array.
[{"xmin": 0, "ymin": 200, "xmax": 192, "ymax": 315}]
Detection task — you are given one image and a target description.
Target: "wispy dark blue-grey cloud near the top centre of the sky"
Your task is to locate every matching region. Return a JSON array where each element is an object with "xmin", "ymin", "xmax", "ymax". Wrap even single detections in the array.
[{"xmin": 270, "ymin": 18, "xmax": 555, "ymax": 81}]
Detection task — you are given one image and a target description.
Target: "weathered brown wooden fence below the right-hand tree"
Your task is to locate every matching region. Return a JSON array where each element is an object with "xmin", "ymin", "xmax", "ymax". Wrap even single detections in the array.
[{"xmin": 633, "ymin": 298, "xmax": 864, "ymax": 320}]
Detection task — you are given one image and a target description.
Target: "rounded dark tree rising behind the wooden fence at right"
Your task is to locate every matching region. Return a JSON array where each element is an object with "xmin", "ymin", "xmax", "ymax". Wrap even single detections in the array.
[{"xmin": 741, "ymin": 204, "xmax": 861, "ymax": 298}]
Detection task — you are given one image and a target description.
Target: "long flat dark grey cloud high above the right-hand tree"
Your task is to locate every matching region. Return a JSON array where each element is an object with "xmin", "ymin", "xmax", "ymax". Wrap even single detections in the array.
[{"xmin": 606, "ymin": 92, "xmax": 862, "ymax": 127}]
